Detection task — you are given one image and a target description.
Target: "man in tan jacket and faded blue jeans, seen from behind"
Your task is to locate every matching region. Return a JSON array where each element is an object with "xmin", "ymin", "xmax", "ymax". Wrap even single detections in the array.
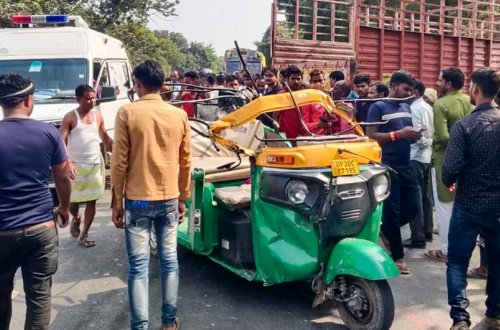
[{"xmin": 111, "ymin": 61, "xmax": 191, "ymax": 330}]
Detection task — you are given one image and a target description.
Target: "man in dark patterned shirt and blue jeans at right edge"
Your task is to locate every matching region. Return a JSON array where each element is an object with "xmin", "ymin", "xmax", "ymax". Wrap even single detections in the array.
[{"xmin": 443, "ymin": 68, "xmax": 500, "ymax": 330}]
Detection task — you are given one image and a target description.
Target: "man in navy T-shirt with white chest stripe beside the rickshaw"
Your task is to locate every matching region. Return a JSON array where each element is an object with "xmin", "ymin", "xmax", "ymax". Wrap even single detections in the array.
[{"xmin": 366, "ymin": 71, "xmax": 422, "ymax": 274}]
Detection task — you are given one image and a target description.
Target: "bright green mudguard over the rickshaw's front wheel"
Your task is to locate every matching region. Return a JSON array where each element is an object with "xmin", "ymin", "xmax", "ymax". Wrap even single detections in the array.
[{"xmin": 323, "ymin": 238, "xmax": 400, "ymax": 285}]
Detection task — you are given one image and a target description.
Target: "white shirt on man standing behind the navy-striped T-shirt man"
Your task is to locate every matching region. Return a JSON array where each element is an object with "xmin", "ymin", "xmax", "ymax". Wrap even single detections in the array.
[{"xmin": 410, "ymin": 97, "xmax": 434, "ymax": 164}]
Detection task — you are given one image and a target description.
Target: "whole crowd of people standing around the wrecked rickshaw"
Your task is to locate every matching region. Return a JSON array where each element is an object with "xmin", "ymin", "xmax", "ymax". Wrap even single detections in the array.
[{"xmin": 0, "ymin": 61, "xmax": 500, "ymax": 330}]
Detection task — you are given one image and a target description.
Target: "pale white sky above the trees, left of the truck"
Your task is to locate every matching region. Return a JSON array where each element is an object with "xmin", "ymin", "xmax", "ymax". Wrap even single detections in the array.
[{"xmin": 148, "ymin": 0, "xmax": 272, "ymax": 56}]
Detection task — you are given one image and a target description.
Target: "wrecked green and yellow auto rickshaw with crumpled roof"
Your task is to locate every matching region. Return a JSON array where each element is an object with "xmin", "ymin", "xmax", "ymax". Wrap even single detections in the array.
[{"xmin": 178, "ymin": 90, "xmax": 399, "ymax": 330}]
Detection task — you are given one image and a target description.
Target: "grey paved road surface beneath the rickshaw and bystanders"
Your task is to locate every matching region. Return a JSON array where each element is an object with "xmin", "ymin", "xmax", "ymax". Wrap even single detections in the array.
[{"xmin": 11, "ymin": 191, "xmax": 485, "ymax": 330}]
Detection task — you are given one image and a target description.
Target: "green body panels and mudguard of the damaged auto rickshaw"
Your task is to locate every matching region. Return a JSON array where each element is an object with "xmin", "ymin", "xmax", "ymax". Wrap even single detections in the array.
[{"xmin": 179, "ymin": 164, "xmax": 399, "ymax": 285}]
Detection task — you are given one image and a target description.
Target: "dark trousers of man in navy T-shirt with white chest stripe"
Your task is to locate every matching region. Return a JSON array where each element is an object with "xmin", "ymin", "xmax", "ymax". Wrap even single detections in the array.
[{"xmin": 381, "ymin": 166, "xmax": 422, "ymax": 260}]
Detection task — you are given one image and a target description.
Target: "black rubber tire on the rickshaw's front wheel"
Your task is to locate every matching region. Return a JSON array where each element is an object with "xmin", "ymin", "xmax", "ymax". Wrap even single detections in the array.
[{"xmin": 338, "ymin": 277, "xmax": 394, "ymax": 330}]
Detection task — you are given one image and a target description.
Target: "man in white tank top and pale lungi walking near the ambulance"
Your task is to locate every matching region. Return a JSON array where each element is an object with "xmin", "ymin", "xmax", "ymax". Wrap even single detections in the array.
[{"xmin": 60, "ymin": 85, "xmax": 113, "ymax": 247}]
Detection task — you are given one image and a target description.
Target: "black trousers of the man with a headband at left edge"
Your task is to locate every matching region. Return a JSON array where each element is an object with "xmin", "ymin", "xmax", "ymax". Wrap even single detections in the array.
[{"xmin": 0, "ymin": 225, "xmax": 58, "ymax": 330}]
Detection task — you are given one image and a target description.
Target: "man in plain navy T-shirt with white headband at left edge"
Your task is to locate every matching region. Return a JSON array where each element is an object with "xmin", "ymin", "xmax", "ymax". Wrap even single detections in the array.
[{"xmin": 0, "ymin": 74, "xmax": 71, "ymax": 329}]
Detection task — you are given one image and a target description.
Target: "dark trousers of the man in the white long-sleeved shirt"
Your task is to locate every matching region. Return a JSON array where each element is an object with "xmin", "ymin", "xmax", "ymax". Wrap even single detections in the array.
[{"xmin": 410, "ymin": 160, "xmax": 434, "ymax": 243}]
